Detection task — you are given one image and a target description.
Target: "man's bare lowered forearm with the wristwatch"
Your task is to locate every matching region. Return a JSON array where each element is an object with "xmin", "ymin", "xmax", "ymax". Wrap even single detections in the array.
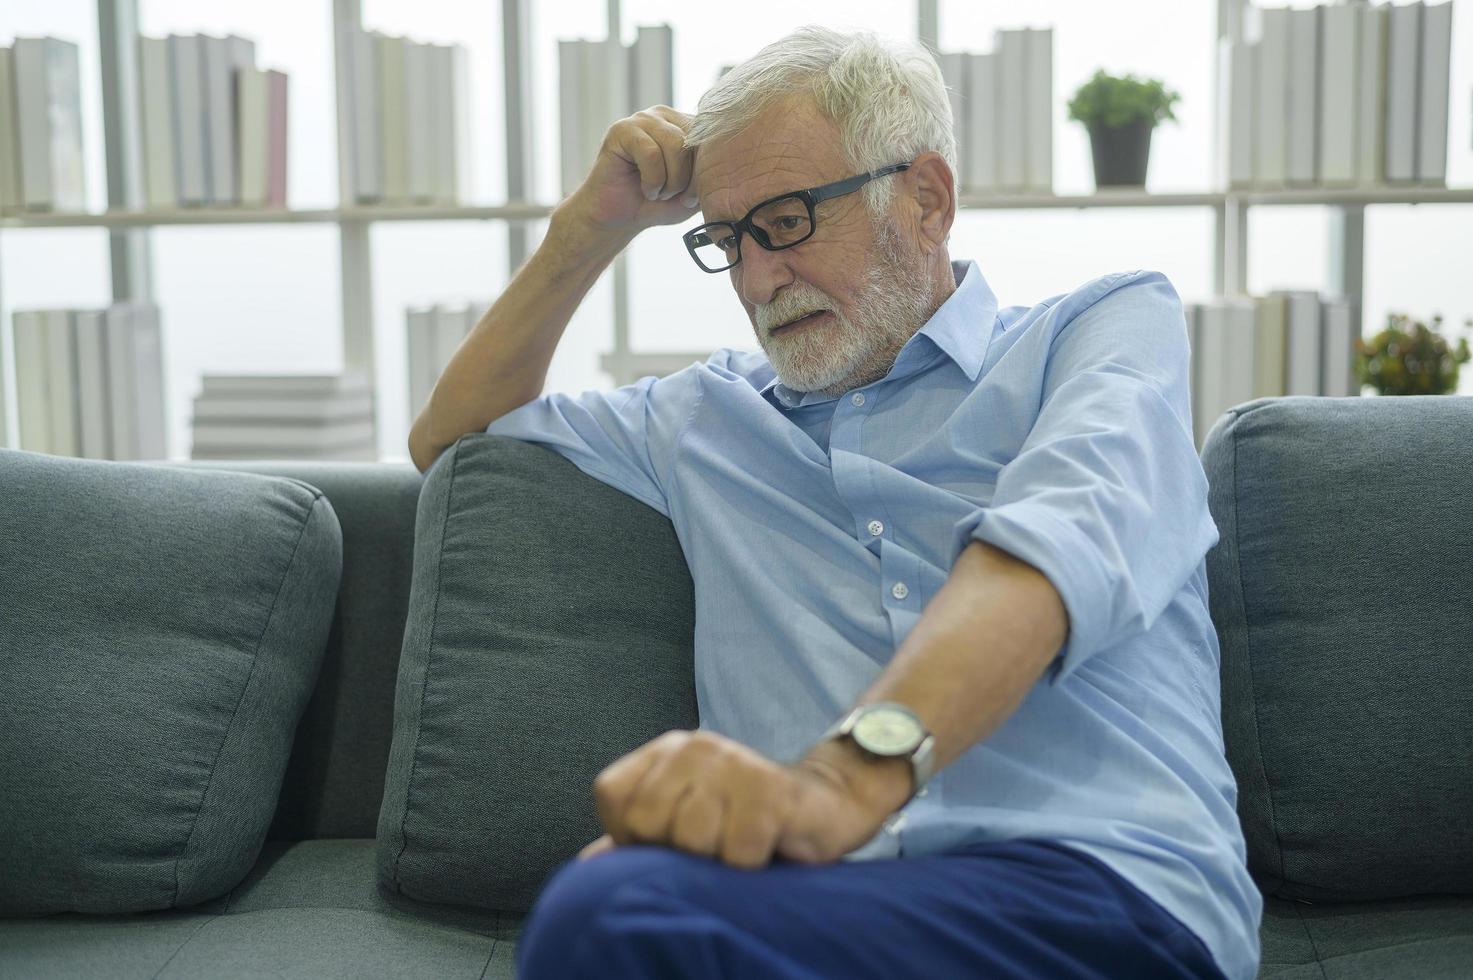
[{"xmin": 803, "ymin": 541, "xmax": 1068, "ymax": 812}]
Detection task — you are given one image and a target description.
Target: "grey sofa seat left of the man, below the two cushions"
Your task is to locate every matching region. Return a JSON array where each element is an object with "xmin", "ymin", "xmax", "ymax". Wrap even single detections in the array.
[{"xmin": 0, "ymin": 839, "xmax": 521, "ymax": 980}]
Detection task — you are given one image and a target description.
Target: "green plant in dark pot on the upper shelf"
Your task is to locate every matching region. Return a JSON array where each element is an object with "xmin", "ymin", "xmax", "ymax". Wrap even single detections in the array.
[{"xmin": 1069, "ymin": 69, "xmax": 1181, "ymax": 187}]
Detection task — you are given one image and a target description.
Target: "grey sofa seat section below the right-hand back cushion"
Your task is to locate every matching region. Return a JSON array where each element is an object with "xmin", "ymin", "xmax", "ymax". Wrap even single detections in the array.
[{"xmin": 1258, "ymin": 896, "xmax": 1473, "ymax": 980}]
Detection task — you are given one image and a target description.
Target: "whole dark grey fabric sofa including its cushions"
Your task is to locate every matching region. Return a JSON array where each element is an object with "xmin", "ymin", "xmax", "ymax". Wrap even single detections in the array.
[{"xmin": 0, "ymin": 398, "xmax": 1473, "ymax": 980}]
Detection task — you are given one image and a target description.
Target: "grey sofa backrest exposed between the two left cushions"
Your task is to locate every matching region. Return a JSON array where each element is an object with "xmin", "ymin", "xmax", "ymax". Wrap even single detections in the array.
[{"xmin": 180, "ymin": 460, "xmax": 424, "ymax": 840}]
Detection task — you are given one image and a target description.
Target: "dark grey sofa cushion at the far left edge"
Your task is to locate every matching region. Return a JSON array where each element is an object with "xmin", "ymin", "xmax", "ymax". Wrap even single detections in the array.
[{"xmin": 0, "ymin": 451, "xmax": 342, "ymax": 915}]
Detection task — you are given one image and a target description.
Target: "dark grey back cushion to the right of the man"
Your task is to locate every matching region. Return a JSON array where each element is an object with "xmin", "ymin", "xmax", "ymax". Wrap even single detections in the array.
[{"xmin": 1202, "ymin": 396, "xmax": 1473, "ymax": 902}]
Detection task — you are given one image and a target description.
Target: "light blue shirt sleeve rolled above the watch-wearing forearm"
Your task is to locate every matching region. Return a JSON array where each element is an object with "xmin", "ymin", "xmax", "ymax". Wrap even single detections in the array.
[{"xmin": 952, "ymin": 273, "xmax": 1217, "ymax": 684}]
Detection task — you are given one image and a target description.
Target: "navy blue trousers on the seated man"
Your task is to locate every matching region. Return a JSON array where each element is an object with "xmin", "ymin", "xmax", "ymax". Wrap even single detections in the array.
[{"xmin": 517, "ymin": 840, "xmax": 1223, "ymax": 980}]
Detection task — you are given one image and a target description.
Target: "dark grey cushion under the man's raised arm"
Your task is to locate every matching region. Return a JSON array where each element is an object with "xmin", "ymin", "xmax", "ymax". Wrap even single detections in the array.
[{"xmin": 379, "ymin": 433, "xmax": 698, "ymax": 911}]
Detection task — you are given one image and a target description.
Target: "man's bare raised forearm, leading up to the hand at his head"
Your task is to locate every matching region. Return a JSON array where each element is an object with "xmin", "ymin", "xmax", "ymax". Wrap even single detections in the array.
[{"xmin": 409, "ymin": 205, "xmax": 627, "ymax": 472}]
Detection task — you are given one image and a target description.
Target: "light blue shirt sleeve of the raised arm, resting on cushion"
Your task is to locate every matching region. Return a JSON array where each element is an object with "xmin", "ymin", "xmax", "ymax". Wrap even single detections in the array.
[{"xmin": 486, "ymin": 365, "xmax": 698, "ymax": 517}]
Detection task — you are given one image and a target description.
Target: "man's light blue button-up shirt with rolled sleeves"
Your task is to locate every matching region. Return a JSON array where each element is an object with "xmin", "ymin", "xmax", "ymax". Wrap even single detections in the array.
[{"xmin": 486, "ymin": 262, "xmax": 1262, "ymax": 980}]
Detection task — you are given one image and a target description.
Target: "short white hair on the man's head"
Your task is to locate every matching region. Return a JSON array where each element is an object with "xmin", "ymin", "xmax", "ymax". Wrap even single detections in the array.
[{"xmin": 685, "ymin": 24, "xmax": 956, "ymax": 220}]
